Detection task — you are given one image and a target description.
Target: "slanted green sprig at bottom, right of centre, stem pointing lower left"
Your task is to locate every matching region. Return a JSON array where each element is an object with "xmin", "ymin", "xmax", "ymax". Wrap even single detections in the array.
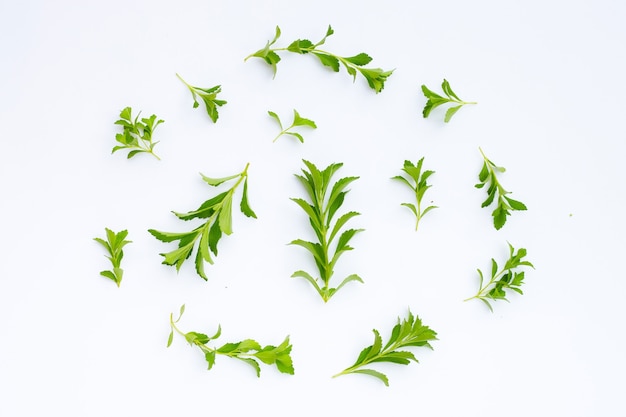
[{"xmin": 333, "ymin": 311, "xmax": 437, "ymax": 386}]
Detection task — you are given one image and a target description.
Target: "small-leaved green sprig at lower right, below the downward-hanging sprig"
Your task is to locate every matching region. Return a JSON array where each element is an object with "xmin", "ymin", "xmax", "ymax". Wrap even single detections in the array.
[{"xmin": 465, "ymin": 243, "xmax": 534, "ymax": 312}]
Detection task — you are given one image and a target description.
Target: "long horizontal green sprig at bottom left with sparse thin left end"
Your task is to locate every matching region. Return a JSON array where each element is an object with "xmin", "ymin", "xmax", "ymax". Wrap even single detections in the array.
[{"xmin": 167, "ymin": 304, "xmax": 294, "ymax": 377}]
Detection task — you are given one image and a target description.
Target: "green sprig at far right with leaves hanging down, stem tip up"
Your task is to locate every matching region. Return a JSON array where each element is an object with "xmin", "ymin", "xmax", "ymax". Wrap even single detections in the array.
[{"xmin": 475, "ymin": 148, "xmax": 526, "ymax": 230}]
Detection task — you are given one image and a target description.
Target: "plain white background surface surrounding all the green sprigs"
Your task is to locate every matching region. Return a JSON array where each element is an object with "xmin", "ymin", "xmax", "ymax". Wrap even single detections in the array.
[{"xmin": 0, "ymin": 0, "xmax": 626, "ymax": 416}]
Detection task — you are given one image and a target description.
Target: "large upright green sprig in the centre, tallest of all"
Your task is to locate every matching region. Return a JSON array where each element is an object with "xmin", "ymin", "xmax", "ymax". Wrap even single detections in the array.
[{"xmin": 290, "ymin": 160, "xmax": 363, "ymax": 302}]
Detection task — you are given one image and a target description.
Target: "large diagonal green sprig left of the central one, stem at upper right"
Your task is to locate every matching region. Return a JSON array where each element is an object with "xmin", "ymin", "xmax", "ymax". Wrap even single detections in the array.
[{"xmin": 148, "ymin": 164, "xmax": 256, "ymax": 280}]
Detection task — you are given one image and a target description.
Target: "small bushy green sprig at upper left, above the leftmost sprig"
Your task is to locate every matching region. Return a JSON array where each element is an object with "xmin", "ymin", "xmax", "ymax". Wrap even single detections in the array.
[{"xmin": 111, "ymin": 107, "xmax": 164, "ymax": 159}]
